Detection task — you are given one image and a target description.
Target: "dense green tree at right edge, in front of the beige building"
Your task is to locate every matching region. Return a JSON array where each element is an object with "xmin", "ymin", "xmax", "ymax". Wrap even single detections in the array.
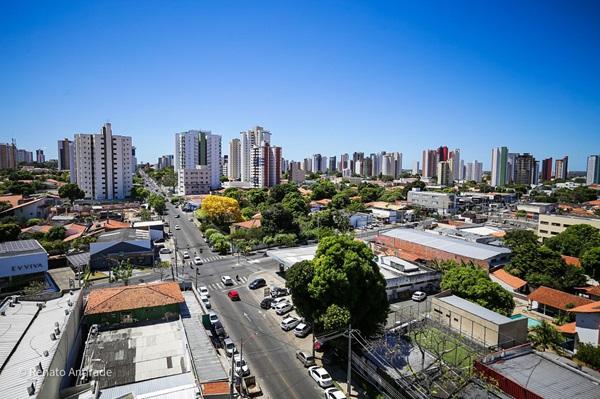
[{"xmin": 544, "ymin": 224, "xmax": 600, "ymax": 257}]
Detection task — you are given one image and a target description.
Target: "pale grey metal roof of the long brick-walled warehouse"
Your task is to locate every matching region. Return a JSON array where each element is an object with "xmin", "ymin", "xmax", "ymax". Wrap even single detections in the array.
[{"xmin": 382, "ymin": 229, "xmax": 510, "ymax": 260}]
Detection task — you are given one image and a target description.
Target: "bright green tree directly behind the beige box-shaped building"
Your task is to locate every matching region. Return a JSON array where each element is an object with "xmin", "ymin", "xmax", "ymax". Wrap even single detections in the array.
[{"xmin": 441, "ymin": 265, "xmax": 515, "ymax": 316}]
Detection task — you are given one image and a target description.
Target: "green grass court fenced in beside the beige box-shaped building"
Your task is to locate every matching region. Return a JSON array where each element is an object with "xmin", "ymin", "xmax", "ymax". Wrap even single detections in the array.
[{"xmin": 410, "ymin": 327, "xmax": 475, "ymax": 370}]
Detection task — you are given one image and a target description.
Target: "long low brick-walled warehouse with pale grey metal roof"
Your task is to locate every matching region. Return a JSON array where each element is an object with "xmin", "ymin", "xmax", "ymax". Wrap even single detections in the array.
[{"xmin": 373, "ymin": 228, "xmax": 511, "ymax": 270}]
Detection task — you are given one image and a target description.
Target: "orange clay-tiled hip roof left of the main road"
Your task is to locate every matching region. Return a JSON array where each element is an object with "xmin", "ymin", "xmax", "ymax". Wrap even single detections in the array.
[{"xmin": 85, "ymin": 282, "xmax": 184, "ymax": 315}]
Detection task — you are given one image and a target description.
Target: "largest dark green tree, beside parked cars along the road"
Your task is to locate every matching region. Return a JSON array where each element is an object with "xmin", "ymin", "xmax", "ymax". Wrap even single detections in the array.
[{"xmin": 286, "ymin": 235, "xmax": 389, "ymax": 336}]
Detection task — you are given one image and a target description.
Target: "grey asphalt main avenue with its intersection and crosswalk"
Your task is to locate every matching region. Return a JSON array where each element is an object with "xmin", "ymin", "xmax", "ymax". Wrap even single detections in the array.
[{"xmin": 147, "ymin": 179, "xmax": 323, "ymax": 399}]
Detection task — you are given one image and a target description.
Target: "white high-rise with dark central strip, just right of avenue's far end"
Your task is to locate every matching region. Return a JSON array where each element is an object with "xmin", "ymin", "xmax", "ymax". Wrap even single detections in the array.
[{"xmin": 175, "ymin": 130, "xmax": 221, "ymax": 195}]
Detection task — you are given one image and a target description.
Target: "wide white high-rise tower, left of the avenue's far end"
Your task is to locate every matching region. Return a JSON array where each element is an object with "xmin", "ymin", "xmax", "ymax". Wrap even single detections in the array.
[{"xmin": 72, "ymin": 123, "xmax": 133, "ymax": 201}]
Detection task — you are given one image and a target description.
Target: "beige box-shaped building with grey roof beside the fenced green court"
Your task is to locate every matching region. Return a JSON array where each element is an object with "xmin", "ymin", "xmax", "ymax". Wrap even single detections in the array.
[{"xmin": 430, "ymin": 291, "xmax": 527, "ymax": 348}]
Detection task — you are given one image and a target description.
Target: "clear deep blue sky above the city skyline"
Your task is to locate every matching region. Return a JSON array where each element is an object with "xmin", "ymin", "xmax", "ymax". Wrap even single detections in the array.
[{"xmin": 0, "ymin": 0, "xmax": 600, "ymax": 170}]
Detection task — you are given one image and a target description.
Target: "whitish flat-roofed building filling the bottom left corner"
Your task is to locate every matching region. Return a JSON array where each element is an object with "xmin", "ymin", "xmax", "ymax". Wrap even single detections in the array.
[{"xmin": 0, "ymin": 290, "xmax": 83, "ymax": 399}]
